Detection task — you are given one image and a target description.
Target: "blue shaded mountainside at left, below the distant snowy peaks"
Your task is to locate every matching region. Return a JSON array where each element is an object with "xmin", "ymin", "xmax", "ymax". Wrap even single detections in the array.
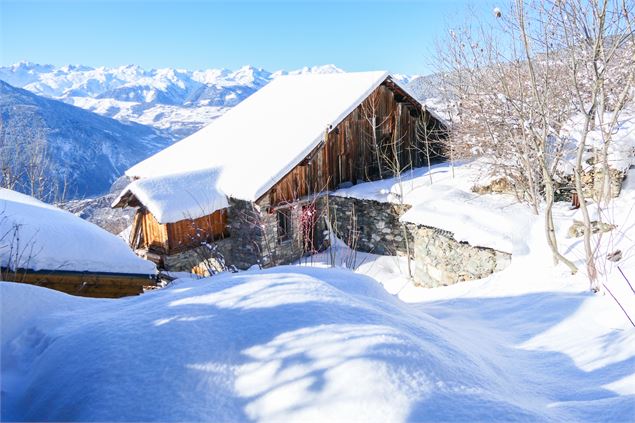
[{"xmin": 0, "ymin": 81, "xmax": 172, "ymax": 197}]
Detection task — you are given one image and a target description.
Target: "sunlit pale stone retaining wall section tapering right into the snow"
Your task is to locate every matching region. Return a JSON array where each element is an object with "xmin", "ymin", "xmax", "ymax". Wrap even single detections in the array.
[{"xmin": 413, "ymin": 226, "xmax": 511, "ymax": 288}]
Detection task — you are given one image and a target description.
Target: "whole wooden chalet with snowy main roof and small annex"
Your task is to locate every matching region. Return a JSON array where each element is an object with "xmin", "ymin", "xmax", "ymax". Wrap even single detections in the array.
[{"xmin": 113, "ymin": 72, "xmax": 447, "ymax": 267}]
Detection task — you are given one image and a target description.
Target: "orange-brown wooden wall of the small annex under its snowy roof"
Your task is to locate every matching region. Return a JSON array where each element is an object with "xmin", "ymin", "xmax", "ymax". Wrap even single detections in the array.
[{"xmin": 130, "ymin": 207, "xmax": 228, "ymax": 254}]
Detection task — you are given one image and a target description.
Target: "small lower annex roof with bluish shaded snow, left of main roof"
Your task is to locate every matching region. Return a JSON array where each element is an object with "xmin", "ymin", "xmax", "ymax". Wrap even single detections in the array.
[{"xmin": 113, "ymin": 168, "xmax": 229, "ymax": 223}]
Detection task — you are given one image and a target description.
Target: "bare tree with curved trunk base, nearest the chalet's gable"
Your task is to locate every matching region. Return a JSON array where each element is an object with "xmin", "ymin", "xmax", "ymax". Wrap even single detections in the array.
[{"xmin": 440, "ymin": 0, "xmax": 577, "ymax": 272}]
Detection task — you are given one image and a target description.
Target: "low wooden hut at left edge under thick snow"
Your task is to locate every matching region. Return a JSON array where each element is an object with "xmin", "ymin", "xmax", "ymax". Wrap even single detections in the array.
[{"xmin": 0, "ymin": 188, "xmax": 156, "ymax": 298}]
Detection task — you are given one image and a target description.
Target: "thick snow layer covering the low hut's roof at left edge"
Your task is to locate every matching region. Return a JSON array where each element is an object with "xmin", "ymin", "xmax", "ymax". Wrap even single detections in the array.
[{"xmin": 0, "ymin": 188, "xmax": 156, "ymax": 274}]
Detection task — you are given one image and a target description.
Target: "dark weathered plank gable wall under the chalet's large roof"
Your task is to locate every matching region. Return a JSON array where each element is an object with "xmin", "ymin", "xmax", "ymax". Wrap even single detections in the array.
[{"xmin": 263, "ymin": 80, "xmax": 445, "ymax": 206}]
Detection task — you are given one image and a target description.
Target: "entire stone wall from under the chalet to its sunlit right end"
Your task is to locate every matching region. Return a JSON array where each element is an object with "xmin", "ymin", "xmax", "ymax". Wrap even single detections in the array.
[{"xmin": 158, "ymin": 196, "xmax": 511, "ymax": 287}]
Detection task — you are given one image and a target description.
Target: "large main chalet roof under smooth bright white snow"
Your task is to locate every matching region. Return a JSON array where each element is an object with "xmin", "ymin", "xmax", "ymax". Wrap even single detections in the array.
[{"xmin": 126, "ymin": 72, "xmax": 404, "ymax": 204}]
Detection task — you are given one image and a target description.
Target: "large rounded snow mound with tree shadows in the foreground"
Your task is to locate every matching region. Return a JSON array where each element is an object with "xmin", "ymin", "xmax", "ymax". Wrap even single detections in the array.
[{"xmin": 0, "ymin": 267, "xmax": 561, "ymax": 422}]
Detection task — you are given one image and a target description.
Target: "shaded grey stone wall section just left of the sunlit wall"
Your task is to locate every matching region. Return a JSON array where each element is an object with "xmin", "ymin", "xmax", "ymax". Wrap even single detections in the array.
[{"xmin": 325, "ymin": 196, "xmax": 413, "ymax": 255}]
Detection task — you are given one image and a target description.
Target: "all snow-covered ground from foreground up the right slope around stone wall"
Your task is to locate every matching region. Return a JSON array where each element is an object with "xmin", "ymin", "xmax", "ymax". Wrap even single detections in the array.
[{"xmin": 0, "ymin": 160, "xmax": 635, "ymax": 422}]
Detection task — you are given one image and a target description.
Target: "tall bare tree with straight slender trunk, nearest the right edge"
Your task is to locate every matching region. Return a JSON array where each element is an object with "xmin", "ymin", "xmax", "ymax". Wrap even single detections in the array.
[{"xmin": 553, "ymin": 0, "xmax": 635, "ymax": 291}]
